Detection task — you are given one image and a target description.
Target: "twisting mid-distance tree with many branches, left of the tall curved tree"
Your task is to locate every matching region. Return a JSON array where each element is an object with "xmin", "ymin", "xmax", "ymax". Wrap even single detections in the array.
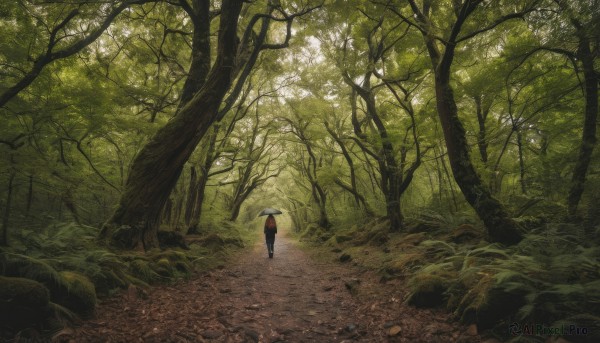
[{"xmin": 340, "ymin": 6, "xmax": 421, "ymax": 231}]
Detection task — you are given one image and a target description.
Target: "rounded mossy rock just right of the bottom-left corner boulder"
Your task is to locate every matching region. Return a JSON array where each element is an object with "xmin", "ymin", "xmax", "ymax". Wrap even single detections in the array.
[{"xmin": 54, "ymin": 271, "xmax": 97, "ymax": 316}]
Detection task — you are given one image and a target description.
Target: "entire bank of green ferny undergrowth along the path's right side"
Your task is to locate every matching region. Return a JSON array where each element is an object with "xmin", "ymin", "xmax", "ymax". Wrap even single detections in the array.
[{"xmin": 300, "ymin": 213, "xmax": 600, "ymax": 342}]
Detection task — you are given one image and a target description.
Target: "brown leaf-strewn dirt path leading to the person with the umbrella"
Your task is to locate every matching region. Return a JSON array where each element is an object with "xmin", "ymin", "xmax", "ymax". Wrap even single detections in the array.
[{"xmin": 55, "ymin": 232, "xmax": 481, "ymax": 342}]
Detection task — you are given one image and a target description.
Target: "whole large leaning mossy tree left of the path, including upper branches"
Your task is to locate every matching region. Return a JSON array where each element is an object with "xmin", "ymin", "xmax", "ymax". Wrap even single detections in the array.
[{"xmin": 101, "ymin": 0, "xmax": 322, "ymax": 249}]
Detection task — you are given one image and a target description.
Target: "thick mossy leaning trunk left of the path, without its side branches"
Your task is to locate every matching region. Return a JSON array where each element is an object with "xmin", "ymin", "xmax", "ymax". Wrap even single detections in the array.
[{"xmin": 101, "ymin": 0, "xmax": 242, "ymax": 250}]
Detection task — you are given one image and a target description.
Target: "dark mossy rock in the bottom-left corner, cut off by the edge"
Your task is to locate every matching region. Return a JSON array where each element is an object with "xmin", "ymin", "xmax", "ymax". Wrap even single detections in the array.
[{"xmin": 0, "ymin": 276, "xmax": 50, "ymax": 331}]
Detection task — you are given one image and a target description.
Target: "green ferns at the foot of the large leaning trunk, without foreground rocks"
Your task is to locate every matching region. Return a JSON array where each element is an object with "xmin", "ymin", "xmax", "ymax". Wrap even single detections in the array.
[{"xmin": 0, "ymin": 223, "xmax": 247, "ymax": 300}]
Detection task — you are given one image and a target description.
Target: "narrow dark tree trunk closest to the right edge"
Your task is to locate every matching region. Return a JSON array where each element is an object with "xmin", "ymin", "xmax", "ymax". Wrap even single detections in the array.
[{"xmin": 567, "ymin": 37, "xmax": 599, "ymax": 216}]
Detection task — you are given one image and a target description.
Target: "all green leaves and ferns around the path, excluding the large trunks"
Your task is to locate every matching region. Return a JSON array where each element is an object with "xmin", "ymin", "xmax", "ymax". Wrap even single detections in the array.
[{"xmin": 0, "ymin": 0, "xmax": 600, "ymax": 342}]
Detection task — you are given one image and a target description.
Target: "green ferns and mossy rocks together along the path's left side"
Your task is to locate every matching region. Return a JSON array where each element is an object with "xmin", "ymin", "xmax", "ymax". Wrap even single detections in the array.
[{"xmin": 0, "ymin": 223, "xmax": 251, "ymax": 339}]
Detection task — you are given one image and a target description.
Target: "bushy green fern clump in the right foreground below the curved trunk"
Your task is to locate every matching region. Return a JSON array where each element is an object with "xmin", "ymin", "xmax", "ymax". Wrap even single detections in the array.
[{"xmin": 404, "ymin": 224, "xmax": 600, "ymax": 342}]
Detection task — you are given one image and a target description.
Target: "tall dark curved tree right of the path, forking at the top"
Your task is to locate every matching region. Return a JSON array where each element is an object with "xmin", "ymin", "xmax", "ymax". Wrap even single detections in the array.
[{"xmin": 393, "ymin": 0, "xmax": 535, "ymax": 244}]
